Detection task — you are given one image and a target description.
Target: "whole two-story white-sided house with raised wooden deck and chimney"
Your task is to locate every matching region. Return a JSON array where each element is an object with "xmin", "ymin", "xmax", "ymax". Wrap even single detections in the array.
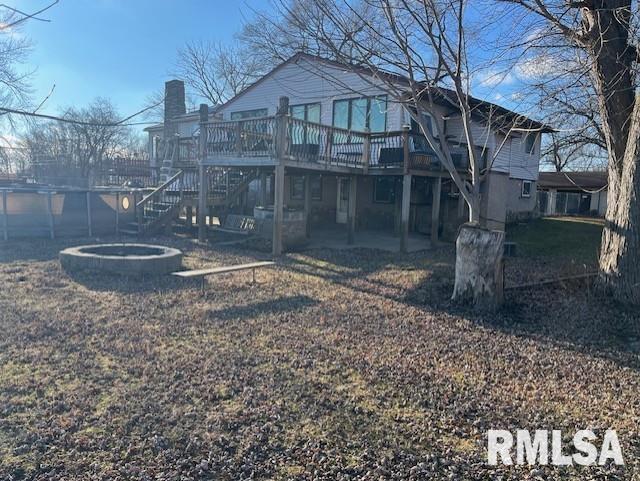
[{"xmin": 146, "ymin": 53, "xmax": 550, "ymax": 255}]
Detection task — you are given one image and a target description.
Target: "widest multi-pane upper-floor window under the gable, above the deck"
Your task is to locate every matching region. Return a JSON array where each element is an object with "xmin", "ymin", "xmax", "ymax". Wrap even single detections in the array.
[{"xmin": 333, "ymin": 95, "xmax": 387, "ymax": 132}]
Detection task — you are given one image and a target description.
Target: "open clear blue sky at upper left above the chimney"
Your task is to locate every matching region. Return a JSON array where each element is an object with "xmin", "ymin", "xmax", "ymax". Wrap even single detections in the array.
[{"xmin": 5, "ymin": 0, "xmax": 267, "ymax": 120}]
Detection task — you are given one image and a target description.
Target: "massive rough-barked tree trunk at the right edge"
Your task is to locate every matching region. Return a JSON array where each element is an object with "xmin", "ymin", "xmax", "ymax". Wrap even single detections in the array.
[{"xmin": 507, "ymin": 0, "xmax": 640, "ymax": 304}]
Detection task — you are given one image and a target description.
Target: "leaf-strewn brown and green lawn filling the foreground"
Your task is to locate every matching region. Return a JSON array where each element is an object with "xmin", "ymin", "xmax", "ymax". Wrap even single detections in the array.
[{"xmin": 0, "ymin": 234, "xmax": 640, "ymax": 481}]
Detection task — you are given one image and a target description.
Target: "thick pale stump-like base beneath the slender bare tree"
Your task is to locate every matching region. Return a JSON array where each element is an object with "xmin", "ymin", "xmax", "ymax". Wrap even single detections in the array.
[{"xmin": 451, "ymin": 224, "xmax": 504, "ymax": 311}]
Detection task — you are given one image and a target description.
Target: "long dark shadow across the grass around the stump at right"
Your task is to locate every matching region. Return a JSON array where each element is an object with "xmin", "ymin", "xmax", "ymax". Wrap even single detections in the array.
[{"xmin": 287, "ymin": 244, "xmax": 640, "ymax": 369}]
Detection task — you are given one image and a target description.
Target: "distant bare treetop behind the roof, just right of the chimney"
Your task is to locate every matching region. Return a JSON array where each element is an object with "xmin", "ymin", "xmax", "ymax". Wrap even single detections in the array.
[{"xmin": 176, "ymin": 41, "xmax": 266, "ymax": 105}]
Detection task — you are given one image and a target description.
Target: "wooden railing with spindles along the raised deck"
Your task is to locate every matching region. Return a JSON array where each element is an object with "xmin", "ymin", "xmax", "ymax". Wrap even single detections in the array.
[{"xmin": 192, "ymin": 116, "xmax": 468, "ymax": 171}]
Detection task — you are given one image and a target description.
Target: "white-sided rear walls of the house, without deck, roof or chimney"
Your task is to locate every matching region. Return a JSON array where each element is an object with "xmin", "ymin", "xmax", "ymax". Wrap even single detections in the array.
[{"xmin": 147, "ymin": 54, "xmax": 544, "ymax": 248}]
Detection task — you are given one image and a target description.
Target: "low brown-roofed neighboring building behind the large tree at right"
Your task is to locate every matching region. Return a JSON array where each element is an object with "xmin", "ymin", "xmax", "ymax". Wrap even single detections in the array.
[{"xmin": 538, "ymin": 172, "xmax": 608, "ymax": 217}]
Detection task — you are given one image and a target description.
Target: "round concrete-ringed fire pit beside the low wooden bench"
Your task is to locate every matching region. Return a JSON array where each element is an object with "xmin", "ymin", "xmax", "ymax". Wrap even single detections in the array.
[{"xmin": 60, "ymin": 244, "xmax": 182, "ymax": 276}]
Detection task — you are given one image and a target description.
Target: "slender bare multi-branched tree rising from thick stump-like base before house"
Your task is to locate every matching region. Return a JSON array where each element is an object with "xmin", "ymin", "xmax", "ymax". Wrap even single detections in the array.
[{"xmin": 264, "ymin": 0, "xmax": 535, "ymax": 307}]
